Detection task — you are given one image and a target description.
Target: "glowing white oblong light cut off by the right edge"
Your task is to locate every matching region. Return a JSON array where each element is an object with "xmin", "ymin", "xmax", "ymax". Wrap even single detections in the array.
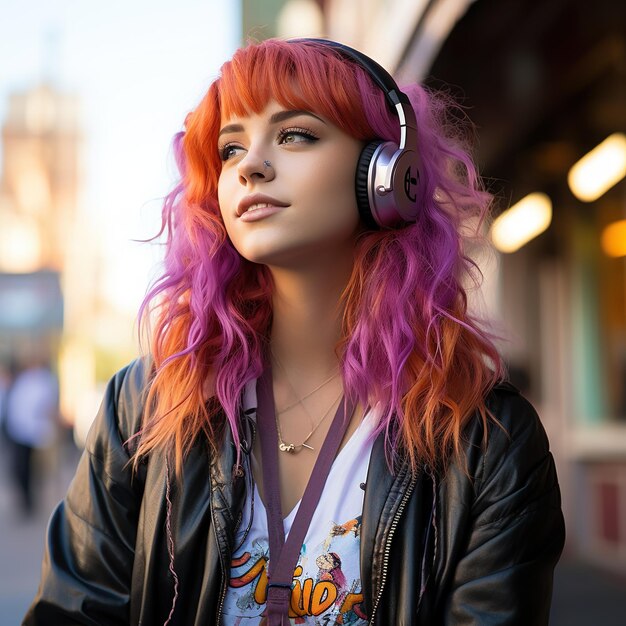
[{"xmin": 567, "ymin": 133, "xmax": 626, "ymax": 202}]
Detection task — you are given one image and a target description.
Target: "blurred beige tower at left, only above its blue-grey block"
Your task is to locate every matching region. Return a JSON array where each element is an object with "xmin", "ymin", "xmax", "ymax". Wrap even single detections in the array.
[{"xmin": 0, "ymin": 85, "xmax": 80, "ymax": 272}]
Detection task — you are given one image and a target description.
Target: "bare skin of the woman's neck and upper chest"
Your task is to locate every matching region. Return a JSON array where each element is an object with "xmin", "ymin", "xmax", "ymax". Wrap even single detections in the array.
[{"xmin": 253, "ymin": 258, "xmax": 361, "ymax": 516}]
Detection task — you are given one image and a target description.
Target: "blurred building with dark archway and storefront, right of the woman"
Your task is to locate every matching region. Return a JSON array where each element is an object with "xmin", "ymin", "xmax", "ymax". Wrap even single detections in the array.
[{"xmin": 243, "ymin": 0, "xmax": 626, "ymax": 572}]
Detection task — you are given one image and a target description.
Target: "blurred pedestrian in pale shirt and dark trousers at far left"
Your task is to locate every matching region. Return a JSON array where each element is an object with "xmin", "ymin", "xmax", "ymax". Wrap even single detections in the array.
[{"xmin": 5, "ymin": 359, "xmax": 59, "ymax": 515}]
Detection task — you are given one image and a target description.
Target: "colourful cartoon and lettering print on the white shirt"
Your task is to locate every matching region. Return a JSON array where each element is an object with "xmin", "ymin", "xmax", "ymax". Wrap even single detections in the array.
[{"xmin": 227, "ymin": 516, "xmax": 367, "ymax": 626}]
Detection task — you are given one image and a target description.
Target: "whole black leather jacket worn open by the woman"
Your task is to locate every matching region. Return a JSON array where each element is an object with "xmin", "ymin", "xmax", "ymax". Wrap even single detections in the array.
[{"xmin": 24, "ymin": 361, "xmax": 564, "ymax": 626}]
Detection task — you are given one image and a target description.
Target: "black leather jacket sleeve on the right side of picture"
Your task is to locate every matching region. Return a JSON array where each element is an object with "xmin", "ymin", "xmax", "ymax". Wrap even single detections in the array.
[{"xmin": 445, "ymin": 389, "xmax": 565, "ymax": 626}]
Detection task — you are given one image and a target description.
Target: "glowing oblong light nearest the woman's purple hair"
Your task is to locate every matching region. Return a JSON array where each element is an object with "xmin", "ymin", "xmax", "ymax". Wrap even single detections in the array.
[{"xmin": 491, "ymin": 192, "xmax": 552, "ymax": 252}]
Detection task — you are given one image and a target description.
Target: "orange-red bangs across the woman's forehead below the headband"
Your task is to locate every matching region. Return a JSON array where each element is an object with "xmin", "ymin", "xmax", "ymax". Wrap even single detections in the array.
[{"xmin": 217, "ymin": 39, "xmax": 380, "ymax": 140}]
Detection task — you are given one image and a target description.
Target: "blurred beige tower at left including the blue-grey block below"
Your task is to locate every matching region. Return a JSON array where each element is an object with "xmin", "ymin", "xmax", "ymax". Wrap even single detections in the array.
[{"xmin": 0, "ymin": 85, "xmax": 80, "ymax": 360}]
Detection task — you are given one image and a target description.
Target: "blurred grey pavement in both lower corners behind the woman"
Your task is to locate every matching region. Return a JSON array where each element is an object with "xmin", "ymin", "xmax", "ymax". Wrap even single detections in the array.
[{"xmin": 0, "ymin": 436, "xmax": 626, "ymax": 626}]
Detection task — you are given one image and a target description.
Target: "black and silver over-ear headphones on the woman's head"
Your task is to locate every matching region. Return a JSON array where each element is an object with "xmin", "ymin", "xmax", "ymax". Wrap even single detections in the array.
[{"xmin": 289, "ymin": 38, "xmax": 419, "ymax": 228}]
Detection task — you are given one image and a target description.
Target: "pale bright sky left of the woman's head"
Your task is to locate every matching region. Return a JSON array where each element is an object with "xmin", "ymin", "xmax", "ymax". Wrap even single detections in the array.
[{"xmin": 0, "ymin": 0, "xmax": 241, "ymax": 314}]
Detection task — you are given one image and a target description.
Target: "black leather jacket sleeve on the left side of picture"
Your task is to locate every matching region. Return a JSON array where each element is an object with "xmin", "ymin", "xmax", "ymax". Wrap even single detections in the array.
[{"xmin": 23, "ymin": 361, "xmax": 150, "ymax": 626}]
